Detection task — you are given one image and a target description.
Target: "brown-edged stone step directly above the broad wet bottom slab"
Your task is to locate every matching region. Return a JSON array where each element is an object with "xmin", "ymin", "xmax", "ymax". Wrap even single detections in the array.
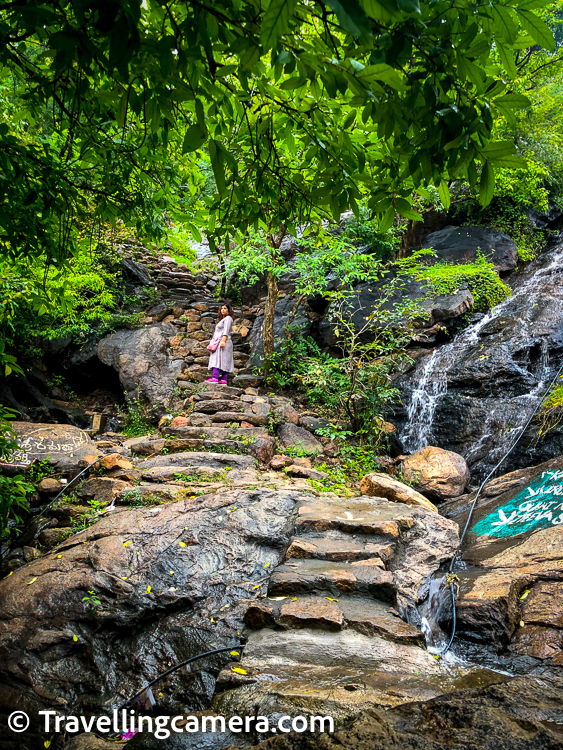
[{"xmin": 244, "ymin": 596, "xmax": 426, "ymax": 648}]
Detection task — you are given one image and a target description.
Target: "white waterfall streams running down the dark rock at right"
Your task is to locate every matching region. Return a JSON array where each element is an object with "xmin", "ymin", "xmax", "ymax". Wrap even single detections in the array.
[{"xmin": 400, "ymin": 245, "xmax": 563, "ymax": 463}]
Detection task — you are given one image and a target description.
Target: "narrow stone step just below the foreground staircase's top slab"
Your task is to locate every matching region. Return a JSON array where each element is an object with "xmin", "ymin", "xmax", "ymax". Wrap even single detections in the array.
[{"xmin": 285, "ymin": 532, "xmax": 395, "ymax": 567}]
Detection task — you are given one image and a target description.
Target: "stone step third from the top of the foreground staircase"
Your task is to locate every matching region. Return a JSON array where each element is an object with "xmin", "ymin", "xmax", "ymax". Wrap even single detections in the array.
[{"xmin": 268, "ymin": 558, "xmax": 395, "ymax": 602}]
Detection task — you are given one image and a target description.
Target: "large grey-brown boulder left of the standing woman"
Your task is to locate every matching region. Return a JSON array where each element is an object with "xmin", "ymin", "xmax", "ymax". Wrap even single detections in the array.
[{"xmin": 98, "ymin": 323, "xmax": 184, "ymax": 416}]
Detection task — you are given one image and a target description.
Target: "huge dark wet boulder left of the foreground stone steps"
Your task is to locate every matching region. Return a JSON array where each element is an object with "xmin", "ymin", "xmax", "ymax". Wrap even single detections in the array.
[{"xmin": 0, "ymin": 490, "xmax": 298, "ymax": 747}]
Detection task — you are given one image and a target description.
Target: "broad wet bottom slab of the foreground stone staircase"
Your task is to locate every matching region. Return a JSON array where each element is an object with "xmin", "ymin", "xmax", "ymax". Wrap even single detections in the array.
[{"xmin": 213, "ymin": 628, "xmax": 482, "ymax": 718}]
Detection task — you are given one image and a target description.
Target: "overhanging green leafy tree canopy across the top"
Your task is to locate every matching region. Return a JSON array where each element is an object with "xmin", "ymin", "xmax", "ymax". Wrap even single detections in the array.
[{"xmin": 0, "ymin": 0, "xmax": 554, "ymax": 270}]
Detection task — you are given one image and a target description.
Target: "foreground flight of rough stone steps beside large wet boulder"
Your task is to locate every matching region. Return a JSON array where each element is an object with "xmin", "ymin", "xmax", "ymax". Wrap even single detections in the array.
[{"xmin": 213, "ymin": 496, "xmax": 484, "ymax": 718}]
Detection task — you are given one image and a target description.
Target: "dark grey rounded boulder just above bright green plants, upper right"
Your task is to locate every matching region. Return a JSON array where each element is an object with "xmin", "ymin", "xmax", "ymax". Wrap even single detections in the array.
[{"xmin": 424, "ymin": 226, "xmax": 518, "ymax": 273}]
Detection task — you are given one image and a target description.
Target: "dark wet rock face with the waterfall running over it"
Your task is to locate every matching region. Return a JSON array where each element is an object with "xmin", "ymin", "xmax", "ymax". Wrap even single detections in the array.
[{"xmin": 393, "ymin": 245, "xmax": 563, "ymax": 480}]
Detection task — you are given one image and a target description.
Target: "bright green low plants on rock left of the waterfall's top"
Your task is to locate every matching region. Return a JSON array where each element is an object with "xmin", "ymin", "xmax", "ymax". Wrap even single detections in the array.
[{"xmin": 417, "ymin": 253, "xmax": 511, "ymax": 312}]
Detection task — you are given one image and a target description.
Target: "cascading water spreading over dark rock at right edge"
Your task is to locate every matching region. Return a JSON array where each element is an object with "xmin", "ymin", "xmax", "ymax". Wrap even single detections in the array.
[{"xmin": 400, "ymin": 245, "xmax": 563, "ymax": 466}]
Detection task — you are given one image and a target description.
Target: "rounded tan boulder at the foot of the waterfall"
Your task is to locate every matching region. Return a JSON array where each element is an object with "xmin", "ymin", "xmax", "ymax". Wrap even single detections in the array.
[{"xmin": 402, "ymin": 445, "xmax": 471, "ymax": 500}]
